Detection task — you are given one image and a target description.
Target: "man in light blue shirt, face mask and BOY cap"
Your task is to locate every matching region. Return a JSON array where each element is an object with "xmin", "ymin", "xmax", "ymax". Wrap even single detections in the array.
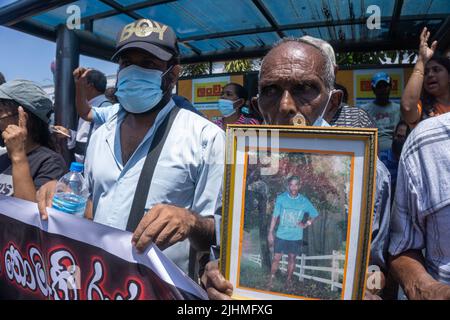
[{"xmin": 38, "ymin": 19, "xmax": 225, "ymax": 278}]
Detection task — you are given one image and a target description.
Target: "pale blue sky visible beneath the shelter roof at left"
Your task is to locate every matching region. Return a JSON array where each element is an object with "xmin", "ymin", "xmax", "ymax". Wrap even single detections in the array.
[{"xmin": 0, "ymin": 26, "xmax": 117, "ymax": 86}]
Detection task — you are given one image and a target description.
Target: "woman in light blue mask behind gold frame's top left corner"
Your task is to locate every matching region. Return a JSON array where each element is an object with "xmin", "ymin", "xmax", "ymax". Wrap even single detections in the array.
[{"xmin": 214, "ymin": 82, "xmax": 259, "ymax": 130}]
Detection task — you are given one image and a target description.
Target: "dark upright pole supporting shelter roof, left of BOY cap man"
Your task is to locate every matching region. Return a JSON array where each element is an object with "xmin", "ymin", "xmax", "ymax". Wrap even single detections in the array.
[{"xmin": 55, "ymin": 25, "xmax": 80, "ymax": 163}]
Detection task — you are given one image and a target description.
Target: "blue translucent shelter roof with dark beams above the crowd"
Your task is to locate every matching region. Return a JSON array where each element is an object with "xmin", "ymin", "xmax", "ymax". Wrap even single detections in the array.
[{"xmin": 0, "ymin": 0, "xmax": 450, "ymax": 63}]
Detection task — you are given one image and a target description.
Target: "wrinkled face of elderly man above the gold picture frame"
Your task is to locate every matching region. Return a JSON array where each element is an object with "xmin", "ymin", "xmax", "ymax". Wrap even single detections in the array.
[{"xmin": 258, "ymin": 41, "xmax": 335, "ymax": 125}]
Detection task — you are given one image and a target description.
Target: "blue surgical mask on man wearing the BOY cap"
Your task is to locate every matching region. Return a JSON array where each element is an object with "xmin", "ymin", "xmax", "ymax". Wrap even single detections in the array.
[{"xmin": 115, "ymin": 64, "xmax": 170, "ymax": 113}]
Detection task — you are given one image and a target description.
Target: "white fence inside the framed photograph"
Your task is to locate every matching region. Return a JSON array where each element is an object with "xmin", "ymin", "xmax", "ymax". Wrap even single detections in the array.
[{"xmin": 246, "ymin": 250, "xmax": 345, "ymax": 291}]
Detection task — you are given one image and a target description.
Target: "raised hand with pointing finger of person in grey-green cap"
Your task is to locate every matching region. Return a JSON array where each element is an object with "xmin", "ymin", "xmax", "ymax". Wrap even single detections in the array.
[{"xmin": 2, "ymin": 107, "xmax": 28, "ymax": 162}]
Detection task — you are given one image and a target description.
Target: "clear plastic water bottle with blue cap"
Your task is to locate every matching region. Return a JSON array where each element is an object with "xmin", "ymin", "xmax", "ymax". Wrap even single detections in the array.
[{"xmin": 53, "ymin": 162, "xmax": 88, "ymax": 217}]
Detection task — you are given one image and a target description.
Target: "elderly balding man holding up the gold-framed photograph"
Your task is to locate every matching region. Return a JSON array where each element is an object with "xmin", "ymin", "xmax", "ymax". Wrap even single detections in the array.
[{"xmin": 201, "ymin": 37, "xmax": 390, "ymax": 299}]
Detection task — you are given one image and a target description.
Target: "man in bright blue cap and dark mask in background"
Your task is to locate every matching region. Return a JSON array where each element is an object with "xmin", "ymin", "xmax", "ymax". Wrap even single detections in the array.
[{"xmin": 361, "ymin": 72, "xmax": 400, "ymax": 152}]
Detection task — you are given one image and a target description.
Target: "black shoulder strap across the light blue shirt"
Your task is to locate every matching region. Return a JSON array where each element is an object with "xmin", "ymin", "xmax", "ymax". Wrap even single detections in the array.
[{"xmin": 127, "ymin": 106, "xmax": 180, "ymax": 232}]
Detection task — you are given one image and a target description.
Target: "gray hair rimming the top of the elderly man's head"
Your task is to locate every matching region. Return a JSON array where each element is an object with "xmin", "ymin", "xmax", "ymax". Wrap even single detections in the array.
[{"xmin": 258, "ymin": 36, "xmax": 336, "ymax": 90}]
